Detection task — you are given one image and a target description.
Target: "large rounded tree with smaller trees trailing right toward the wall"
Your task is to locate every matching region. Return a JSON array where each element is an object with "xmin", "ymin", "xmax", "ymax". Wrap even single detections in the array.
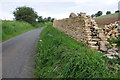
[{"xmin": 13, "ymin": 6, "xmax": 55, "ymax": 25}]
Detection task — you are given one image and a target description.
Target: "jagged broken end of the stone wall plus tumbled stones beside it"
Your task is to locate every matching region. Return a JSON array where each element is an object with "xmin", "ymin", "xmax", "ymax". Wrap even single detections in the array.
[{"xmin": 75, "ymin": 14, "xmax": 120, "ymax": 58}]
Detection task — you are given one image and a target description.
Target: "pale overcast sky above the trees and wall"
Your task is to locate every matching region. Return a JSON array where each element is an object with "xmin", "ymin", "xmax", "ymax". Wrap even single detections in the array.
[{"xmin": 0, "ymin": 0, "xmax": 119, "ymax": 20}]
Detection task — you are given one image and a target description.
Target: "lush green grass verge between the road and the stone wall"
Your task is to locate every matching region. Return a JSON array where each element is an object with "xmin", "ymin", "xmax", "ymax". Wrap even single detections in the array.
[{"xmin": 34, "ymin": 24, "xmax": 118, "ymax": 78}]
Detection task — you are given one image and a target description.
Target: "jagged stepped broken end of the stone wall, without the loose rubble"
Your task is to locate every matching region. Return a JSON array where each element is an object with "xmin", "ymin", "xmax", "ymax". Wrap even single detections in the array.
[{"xmin": 79, "ymin": 14, "xmax": 100, "ymax": 50}]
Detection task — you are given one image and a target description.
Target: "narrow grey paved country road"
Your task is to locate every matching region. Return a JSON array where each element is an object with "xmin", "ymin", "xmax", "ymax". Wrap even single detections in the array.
[{"xmin": 2, "ymin": 28, "xmax": 42, "ymax": 78}]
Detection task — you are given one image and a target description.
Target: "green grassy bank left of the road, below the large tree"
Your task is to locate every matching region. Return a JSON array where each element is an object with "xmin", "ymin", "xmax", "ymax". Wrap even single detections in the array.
[{"xmin": 1, "ymin": 21, "xmax": 43, "ymax": 41}]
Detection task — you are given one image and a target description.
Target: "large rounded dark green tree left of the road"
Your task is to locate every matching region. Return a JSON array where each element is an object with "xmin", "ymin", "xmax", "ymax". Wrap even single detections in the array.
[{"xmin": 13, "ymin": 6, "xmax": 38, "ymax": 24}]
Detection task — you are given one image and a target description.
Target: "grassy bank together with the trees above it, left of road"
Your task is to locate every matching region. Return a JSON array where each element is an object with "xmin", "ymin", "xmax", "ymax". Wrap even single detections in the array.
[{"xmin": 0, "ymin": 6, "xmax": 54, "ymax": 42}]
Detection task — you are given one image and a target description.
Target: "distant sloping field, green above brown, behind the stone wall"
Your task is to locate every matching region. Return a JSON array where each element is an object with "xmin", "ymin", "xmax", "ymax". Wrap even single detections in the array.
[{"xmin": 94, "ymin": 13, "xmax": 120, "ymax": 26}]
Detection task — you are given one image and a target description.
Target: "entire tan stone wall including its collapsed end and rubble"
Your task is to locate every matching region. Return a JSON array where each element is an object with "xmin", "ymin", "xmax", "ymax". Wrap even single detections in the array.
[{"xmin": 53, "ymin": 13, "xmax": 119, "ymax": 57}]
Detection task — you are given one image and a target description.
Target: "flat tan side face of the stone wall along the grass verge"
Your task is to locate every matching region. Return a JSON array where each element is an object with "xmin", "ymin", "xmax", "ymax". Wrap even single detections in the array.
[{"xmin": 53, "ymin": 17, "xmax": 86, "ymax": 41}]
